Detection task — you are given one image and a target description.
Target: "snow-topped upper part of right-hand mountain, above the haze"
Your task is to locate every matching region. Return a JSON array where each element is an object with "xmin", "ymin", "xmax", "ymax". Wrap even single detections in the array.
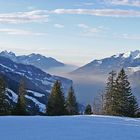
[{"xmin": 72, "ymin": 50, "xmax": 140, "ymax": 74}]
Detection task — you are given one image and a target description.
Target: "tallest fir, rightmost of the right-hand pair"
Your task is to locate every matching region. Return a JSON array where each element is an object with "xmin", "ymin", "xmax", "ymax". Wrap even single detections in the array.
[{"xmin": 114, "ymin": 69, "xmax": 138, "ymax": 117}]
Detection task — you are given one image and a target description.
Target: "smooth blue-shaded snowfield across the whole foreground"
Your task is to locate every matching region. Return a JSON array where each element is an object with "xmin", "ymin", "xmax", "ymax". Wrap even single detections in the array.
[{"xmin": 0, "ymin": 116, "xmax": 140, "ymax": 140}]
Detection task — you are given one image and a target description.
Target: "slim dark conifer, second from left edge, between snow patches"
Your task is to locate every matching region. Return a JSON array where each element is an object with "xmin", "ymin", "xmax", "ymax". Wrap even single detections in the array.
[{"xmin": 13, "ymin": 80, "xmax": 28, "ymax": 115}]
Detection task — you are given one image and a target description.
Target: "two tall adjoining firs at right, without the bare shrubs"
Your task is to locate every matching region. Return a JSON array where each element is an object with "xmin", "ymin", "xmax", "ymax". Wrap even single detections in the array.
[{"xmin": 105, "ymin": 69, "xmax": 138, "ymax": 117}]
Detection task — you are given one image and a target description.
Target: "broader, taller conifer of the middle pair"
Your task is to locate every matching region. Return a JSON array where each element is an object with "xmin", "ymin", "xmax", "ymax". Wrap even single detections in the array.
[{"xmin": 46, "ymin": 81, "xmax": 66, "ymax": 116}]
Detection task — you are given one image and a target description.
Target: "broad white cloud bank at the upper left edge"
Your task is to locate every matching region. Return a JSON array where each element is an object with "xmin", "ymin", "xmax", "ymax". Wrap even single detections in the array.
[{"xmin": 0, "ymin": 10, "xmax": 48, "ymax": 24}]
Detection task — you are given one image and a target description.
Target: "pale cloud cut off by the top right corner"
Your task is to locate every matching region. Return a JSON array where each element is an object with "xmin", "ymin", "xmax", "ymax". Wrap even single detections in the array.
[{"xmin": 104, "ymin": 0, "xmax": 140, "ymax": 7}]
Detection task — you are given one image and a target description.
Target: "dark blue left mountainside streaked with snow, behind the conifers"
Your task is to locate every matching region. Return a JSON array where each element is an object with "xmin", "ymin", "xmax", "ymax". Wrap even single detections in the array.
[{"xmin": 0, "ymin": 56, "xmax": 72, "ymax": 113}]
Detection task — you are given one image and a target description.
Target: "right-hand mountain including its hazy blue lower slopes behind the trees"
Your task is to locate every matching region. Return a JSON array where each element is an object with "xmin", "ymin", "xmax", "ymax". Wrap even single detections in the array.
[{"xmin": 70, "ymin": 50, "xmax": 140, "ymax": 104}]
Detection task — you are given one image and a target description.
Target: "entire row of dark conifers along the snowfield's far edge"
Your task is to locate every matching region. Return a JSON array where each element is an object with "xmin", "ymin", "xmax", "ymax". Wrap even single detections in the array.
[{"xmin": 0, "ymin": 69, "xmax": 140, "ymax": 117}]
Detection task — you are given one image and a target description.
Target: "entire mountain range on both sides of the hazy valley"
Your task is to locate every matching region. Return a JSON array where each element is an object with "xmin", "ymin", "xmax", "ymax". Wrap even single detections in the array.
[{"xmin": 0, "ymin": 50, "xmax": 140, "ymax": 108}]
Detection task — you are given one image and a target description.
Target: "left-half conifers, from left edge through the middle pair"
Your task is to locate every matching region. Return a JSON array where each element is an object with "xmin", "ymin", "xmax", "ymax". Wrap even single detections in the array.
[{"xmin": 0, "ymin": 76, "xmax": 79, "ymax": 116}]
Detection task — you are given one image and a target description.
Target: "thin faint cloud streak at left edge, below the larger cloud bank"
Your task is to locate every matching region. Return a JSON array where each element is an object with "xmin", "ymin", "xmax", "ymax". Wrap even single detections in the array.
[{"xmin": 0, "ymin": 28, "xmax": 46, "ymax": 36}]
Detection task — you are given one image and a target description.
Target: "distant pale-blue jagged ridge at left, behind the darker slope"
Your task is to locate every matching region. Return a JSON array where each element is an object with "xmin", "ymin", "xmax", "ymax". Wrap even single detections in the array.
[{"xmin": 0, "ymin": 51, "xmax": 65, "ymax": 70}]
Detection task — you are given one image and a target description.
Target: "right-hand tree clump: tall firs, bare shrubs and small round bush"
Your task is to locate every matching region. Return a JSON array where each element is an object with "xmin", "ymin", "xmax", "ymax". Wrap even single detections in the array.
[{"xmin": 85, "ymin": 69, "xmax": 140, "ymax": 117}]
